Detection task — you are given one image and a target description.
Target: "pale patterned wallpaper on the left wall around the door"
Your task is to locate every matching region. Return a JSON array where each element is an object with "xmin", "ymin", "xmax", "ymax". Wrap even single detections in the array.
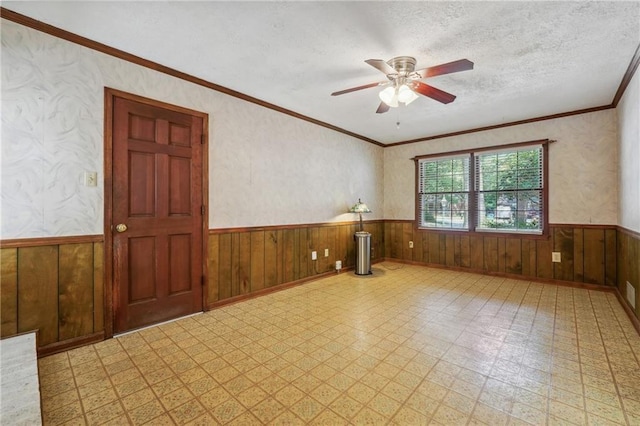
[{"xmin": 0, "ymin": 20, "xmax": 384, "ymax": 239}]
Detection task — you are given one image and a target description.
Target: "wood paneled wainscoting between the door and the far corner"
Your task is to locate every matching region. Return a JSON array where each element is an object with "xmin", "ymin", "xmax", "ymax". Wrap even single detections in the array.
[{"xmin": 205, "ymin": 221, "xmax": 385, "ymax": 308}]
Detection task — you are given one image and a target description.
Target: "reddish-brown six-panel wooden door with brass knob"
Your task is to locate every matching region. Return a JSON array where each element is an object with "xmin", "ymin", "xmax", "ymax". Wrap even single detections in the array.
[{"xmin": 111, "ymin": 97, "xmax": 204, "ymax": 333}]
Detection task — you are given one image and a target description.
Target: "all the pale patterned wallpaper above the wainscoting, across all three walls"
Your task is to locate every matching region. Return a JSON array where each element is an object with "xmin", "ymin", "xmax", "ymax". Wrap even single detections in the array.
[{"xmin": 0, "ymin": 20, "xmax": 640, "ymax": 238}]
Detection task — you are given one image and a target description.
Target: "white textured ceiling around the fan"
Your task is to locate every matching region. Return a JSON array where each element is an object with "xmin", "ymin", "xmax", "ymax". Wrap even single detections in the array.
[{"xmin": 2, "ymin": 1, "xmax": 640, "ymax": 144}]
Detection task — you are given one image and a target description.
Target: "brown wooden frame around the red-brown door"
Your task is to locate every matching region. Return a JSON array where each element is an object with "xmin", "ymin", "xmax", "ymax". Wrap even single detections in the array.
[{"xmin": 104, "ymin": 87, "xmax": 209, "ymax": 339}]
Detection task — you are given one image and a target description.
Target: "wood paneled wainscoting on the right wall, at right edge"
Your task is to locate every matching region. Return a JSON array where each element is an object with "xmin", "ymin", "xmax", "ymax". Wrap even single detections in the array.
[{"xmin": 618, "ymin": 227, "xmax": 640, "ymax": 324}]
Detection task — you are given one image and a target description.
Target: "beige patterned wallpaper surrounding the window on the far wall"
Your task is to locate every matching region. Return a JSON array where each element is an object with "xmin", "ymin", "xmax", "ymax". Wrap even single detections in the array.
[{"xmin": 384, "ymin": 109, "xmax": 618, "ymax": 225}]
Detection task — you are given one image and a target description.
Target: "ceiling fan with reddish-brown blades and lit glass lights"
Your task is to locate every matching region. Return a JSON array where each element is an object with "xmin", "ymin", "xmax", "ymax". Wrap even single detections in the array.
[{"xmin": 331, "ymin": 56, "xmax": 473, "ymax": 114}]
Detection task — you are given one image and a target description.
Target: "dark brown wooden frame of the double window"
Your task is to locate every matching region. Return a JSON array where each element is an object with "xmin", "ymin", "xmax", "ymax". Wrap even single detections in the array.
[{"xmin": 412, "ymin": 139, "xmax": 552, "ymax": 239}]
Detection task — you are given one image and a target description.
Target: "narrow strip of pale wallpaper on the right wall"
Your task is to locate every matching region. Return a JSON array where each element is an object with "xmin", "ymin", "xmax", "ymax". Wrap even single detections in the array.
[{"xmin": 617, "ymin": 70, "xmax": 640, "ymax": 232}]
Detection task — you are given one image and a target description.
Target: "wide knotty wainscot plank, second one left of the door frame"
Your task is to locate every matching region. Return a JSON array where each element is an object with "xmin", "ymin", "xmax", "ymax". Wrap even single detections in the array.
[{"xmin": 58, "ymin": 243, "xmax": 94, "ymax": 340}]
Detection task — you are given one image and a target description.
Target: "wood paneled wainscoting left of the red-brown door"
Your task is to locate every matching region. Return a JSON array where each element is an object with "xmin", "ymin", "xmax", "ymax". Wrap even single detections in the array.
[{"xmin": 0, "ymin": 235, "xmax": 104, "ymax": 355}]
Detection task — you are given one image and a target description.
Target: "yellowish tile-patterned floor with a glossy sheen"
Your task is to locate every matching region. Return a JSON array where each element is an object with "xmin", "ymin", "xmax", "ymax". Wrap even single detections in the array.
[{"xmin": 39, "ymin": 262, "xmax": 640, "ymax": 425}]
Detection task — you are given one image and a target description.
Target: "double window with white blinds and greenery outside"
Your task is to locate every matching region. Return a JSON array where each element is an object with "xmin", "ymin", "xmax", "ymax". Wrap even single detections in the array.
[{"xmin": 416, "ymin": 141, "xmax": 547, "ymax": 234}]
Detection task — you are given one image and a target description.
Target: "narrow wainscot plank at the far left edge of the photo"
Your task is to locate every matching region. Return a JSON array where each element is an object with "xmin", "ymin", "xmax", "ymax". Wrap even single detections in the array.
[{"xmin": 0, "ymin": 248, "xmax": 18, "ymax": 337}]
